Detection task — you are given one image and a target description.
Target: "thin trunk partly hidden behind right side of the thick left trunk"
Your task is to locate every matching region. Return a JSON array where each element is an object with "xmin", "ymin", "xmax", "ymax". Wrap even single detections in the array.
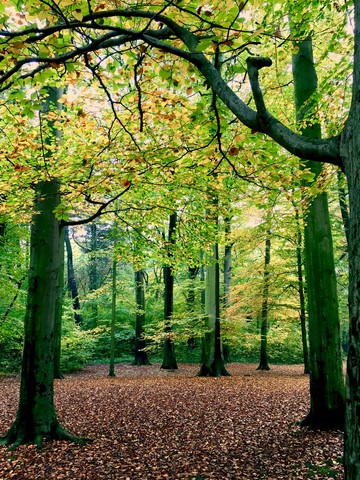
[{"xmin": 54, "ymin": 226, "xmax": 65, "ymax": 378}]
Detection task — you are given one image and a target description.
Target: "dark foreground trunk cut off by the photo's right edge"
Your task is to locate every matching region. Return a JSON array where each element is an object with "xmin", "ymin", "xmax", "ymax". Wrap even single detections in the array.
[{"xmin": 340, "ymin": 0, "xmax": 360, "ymax": 468}]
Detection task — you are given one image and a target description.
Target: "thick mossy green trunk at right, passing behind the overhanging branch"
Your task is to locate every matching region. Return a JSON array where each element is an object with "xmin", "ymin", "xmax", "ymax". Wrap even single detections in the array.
[{"xmin": 293, "ymin": 38, "xmax": 345, "ymax": 429}]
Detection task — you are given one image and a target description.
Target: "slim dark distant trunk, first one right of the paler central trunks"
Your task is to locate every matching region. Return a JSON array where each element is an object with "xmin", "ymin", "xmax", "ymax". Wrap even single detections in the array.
[{"xmin": 256, "ymin": 228, "xmax": 271, "ymax": 370}]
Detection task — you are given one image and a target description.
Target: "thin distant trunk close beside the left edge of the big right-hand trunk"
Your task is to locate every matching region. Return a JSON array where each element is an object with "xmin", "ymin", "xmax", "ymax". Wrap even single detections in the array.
[{"xmin": 295, "ymin": 207, "xmax": 310, "ymax": 374}]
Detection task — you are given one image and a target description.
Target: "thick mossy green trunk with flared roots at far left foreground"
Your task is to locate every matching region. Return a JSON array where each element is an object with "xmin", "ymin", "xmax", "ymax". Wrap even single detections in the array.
[{"xmin": 1, "ymin": 87, "xmax": 79, "ymax": 448}]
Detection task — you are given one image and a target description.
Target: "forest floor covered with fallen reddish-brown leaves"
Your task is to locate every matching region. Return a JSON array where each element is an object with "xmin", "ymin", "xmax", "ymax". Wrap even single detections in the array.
[{"xmin": 0, "ymin": 363, "xmax": 343, "ymax": 480}]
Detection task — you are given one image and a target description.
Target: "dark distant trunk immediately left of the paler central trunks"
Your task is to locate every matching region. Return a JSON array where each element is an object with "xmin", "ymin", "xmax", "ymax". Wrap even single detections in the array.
[{"xmin": 161, "ymin": 213, "xmax": 178, "ymax": 370}]
